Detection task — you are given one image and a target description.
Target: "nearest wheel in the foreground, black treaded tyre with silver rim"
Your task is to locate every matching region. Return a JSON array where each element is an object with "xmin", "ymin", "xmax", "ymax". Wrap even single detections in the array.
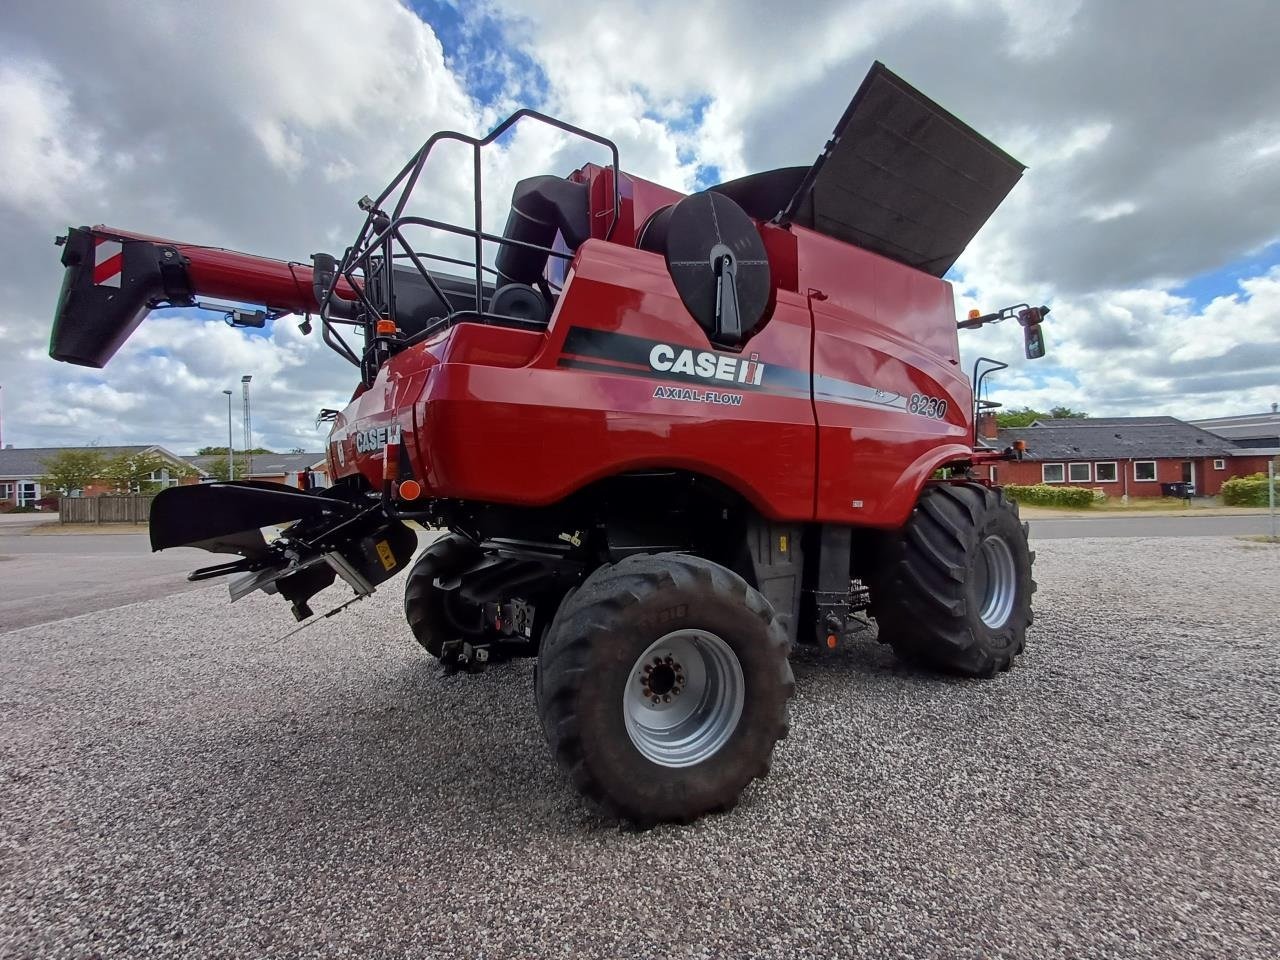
[{"xmin": 538, "ymin": 553, "xmax": 795, "ymax": 827}]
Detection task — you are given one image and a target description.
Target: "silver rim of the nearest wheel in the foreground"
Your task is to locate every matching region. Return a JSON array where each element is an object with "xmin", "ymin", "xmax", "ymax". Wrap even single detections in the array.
[{"xmin": 622, "ymin": 630, "xmax": 746, "ymax": 767}]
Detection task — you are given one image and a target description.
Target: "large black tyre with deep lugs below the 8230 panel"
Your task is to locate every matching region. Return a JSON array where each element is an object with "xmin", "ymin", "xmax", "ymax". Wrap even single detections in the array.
[{"xmin": 872, "ymin": 484, "xmax": 1036, "ymax": 677}]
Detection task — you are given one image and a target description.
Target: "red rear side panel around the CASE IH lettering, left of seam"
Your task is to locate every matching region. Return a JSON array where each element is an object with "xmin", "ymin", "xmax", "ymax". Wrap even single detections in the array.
[{"xmin": 330, "ymin": 241, "xmax": 815, "ymax": 518}]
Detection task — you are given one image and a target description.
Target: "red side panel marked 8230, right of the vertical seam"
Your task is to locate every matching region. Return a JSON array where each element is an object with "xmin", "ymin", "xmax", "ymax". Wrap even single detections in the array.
[{"xmin": 794, "ymin": 227, "xmax": 973, "ymax": 526}]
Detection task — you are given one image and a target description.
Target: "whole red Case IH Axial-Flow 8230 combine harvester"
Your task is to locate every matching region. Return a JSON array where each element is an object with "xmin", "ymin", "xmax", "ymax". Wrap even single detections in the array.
[{"xmin": 50, "ymin": 64, "xmax": 1044, "ymax": 824}]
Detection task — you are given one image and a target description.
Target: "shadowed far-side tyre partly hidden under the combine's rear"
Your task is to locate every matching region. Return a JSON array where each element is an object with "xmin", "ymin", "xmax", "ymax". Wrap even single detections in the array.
[{"xmin": 404, "ymin": 534, "xmax": 486, "ymax": 659}]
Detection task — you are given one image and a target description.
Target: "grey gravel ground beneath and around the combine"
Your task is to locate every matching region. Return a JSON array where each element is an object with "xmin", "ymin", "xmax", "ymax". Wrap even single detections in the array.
[{"xmin": 0, "ymin": 539, "xmax": 1280, "ymax": 959}]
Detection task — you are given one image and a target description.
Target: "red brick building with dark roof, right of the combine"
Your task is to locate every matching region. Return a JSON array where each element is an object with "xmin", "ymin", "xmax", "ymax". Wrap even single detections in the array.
[{"xmin": 979, "ymin": 415, "xmax": 1270, "ymax": 497}]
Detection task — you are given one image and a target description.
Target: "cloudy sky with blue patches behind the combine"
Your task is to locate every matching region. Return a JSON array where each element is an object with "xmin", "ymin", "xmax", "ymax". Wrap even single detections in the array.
[{"xmin": 0, "ymin": 0, "xmax": 1280, "ymax": 452}]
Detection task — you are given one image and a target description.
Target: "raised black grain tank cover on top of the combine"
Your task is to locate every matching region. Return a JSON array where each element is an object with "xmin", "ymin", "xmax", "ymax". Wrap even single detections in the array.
[{"xmin": 712, "ymin": 61, "xmax": 1027, "ymax": 276}]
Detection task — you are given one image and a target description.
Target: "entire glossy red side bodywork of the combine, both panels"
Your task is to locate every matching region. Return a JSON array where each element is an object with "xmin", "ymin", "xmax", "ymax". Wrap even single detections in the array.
[{"xmin": 330, "ymin": 161, "xmax": 972, "ymax": 527}]
